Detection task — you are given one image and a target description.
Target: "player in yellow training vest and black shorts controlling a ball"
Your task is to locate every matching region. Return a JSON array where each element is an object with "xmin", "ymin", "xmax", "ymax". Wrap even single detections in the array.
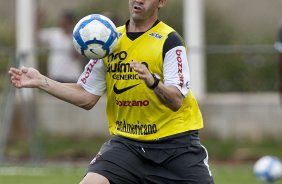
[{"xmin": 9, "ymin": 0, "xmax": 214, "ymax": 184}]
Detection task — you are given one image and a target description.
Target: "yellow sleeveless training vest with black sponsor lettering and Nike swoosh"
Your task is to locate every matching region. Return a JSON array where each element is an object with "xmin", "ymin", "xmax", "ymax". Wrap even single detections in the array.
[{"xmin": 104, "ymin": 22, "xmax": 203, "ymax": 140}]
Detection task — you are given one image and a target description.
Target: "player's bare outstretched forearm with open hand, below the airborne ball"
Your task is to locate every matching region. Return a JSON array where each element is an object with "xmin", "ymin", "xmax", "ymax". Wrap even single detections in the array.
[{"xmin": 8, "ymin": 67, "xmax": 100, "ymax": 110}]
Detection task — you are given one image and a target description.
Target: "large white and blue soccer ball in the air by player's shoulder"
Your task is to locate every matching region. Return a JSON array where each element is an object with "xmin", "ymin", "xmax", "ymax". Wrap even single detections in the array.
[{"xmin": 73, "ymin": 14, "xmax": 118, "ymax": 59}]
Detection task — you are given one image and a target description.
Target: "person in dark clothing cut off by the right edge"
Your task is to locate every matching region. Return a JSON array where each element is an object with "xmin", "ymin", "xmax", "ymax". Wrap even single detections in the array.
[{"xmin": 275, "ymin": 27, "xmax": 282, "ymax": 102}]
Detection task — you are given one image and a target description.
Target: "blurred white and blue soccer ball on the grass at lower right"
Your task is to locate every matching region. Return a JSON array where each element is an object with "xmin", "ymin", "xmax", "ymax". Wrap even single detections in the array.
[{"xmin": 253, "ymin": 156, "xmax": 282, "ymax": 183}]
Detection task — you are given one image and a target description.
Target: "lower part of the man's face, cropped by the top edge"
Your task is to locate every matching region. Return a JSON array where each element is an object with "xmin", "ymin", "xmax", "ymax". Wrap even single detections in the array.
[{"xmin": 129, "ymin": 0, "xmax": 160, "ymax": 21}]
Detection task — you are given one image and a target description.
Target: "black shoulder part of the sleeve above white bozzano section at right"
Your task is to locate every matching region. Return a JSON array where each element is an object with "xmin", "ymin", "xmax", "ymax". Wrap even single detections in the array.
[{"xmin": 163, "ymin": 32, "xmax": 185, "ymax": 58}]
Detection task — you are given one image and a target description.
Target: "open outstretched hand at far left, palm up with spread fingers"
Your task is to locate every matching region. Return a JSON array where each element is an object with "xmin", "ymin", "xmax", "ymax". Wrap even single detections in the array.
[{"xmin": 8, "ymin": 67, "xmax": 40, "ymax": 88}]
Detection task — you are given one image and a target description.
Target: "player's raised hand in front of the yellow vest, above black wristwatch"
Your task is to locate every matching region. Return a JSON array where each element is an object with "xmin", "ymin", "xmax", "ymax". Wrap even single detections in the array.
[{"xmin": 130, "ymin": 61, "xmax": 154, "ymax": 86}]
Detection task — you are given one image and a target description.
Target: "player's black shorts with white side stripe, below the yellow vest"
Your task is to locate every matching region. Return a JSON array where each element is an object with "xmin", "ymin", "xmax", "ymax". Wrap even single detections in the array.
[{"xmin": 88, "ymin": 131, "xmax": 214, "ymax": 184}]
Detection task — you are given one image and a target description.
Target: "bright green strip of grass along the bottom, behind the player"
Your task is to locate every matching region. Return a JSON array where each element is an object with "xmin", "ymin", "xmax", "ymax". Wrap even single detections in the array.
[{"xmin": 0, "ymin": 163, "xmax": 282, "ymax": 184}]
